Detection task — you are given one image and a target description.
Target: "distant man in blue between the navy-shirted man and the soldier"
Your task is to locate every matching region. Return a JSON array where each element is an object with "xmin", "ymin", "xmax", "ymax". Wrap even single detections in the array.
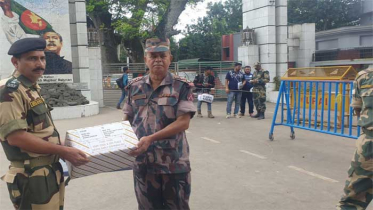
[{"xmin": 240, "ymin": 66, "xmax": 254, "ymax": 116}]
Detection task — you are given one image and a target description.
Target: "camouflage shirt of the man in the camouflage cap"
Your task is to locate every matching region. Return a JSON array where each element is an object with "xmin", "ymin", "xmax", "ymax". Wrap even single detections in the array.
[{"xmin": 123, "ymin": 73, "xmax": 196, "ymax": 174}]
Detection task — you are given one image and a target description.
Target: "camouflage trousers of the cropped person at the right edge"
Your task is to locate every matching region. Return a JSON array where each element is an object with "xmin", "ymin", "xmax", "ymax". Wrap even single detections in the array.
[{"xmin": 337, "ymin": 134, "xmax": 373, "ymax": 210}]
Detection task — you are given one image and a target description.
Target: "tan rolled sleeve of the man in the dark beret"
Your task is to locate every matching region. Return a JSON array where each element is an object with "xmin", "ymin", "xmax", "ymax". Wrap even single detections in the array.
[{"xmin": 0, "ymin": 87, "xmax": 28, "ymax": 141}]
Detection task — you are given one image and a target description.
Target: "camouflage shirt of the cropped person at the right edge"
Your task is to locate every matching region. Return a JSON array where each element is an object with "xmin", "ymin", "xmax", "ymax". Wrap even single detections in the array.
[{"xmin": 351, "ymin": 69, "xmax": 373, "ymax": 130}]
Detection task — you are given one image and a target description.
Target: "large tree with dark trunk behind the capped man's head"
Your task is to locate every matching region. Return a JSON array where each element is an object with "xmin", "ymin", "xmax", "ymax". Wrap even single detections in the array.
[{"xmin": 86, "ymin": 0, "xmax": 199, "ymax": 63}]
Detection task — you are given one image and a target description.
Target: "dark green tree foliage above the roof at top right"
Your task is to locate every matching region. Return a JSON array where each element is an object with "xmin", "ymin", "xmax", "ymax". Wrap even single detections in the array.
[{"xmin": 288, "ymin": 0, "xmax": 361, "ymax": 31}]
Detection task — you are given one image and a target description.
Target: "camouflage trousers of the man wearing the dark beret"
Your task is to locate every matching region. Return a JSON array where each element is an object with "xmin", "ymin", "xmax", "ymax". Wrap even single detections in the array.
[{"xmin": 2, "ymin": 163, "xmax": 65, "ymax": 210}]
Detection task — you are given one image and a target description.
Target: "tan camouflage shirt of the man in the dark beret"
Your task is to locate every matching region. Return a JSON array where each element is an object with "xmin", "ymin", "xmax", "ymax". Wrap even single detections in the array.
[{"xmin": 0, "ymin": 71, "xmax": 60, "ymax": 161}]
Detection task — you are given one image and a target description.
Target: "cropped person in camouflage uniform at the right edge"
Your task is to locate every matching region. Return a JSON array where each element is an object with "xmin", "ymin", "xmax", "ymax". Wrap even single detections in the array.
[{"xmin": 337, "ymin": 68, "xmax": 373, "ymax": 210}]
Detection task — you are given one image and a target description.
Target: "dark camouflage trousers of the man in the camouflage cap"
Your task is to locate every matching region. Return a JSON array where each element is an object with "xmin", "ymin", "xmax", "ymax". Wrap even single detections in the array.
[{"xmin": 133, "ymin": 170, "xmax": 191, "ymax": 210}]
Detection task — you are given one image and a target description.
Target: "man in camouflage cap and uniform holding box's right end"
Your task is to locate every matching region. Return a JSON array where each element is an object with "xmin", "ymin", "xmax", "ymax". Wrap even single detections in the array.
[{"xmin": 123, "ymin": 38, "xmax": 196, "ymax": 209}]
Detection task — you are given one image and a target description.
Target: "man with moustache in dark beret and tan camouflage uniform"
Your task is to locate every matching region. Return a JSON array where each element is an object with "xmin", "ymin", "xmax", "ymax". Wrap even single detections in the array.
[{"xmin": 0, "ymin": 38, "xmax": 88, "ymax": 210}]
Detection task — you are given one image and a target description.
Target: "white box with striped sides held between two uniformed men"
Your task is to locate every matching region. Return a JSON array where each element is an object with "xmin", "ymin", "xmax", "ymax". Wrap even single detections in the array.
[{"xmin": 65, "ymin": 121, "xmax": 138, "ymax": 179}]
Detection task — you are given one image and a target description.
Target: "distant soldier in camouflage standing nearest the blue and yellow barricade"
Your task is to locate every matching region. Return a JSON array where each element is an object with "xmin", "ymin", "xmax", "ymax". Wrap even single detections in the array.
[{"xmin": 250, "ymin": 62, "xmax": 269, "ymax": 120}]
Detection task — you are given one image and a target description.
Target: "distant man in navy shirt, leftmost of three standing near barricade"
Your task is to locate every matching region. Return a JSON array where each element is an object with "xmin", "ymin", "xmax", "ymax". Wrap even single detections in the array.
[{"xmin": 225, "ymin": 63, "xmax": 246, "ymax": 119}]
